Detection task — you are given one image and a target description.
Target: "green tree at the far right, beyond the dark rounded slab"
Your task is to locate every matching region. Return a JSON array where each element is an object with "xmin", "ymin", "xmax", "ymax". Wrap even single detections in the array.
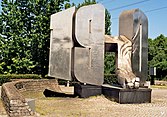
[{"xmin": 148, "ymin": 34, "xmax": 167, "ymax": 79}]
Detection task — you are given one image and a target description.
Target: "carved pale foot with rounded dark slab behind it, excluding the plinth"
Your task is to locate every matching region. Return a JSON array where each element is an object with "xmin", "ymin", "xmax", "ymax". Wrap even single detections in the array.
[{"xmin": 105, "ymin": 9, "xmax": 148, "ymax": 88}]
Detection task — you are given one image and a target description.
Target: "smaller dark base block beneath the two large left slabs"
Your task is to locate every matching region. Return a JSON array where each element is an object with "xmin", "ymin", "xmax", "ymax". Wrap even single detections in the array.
[{"xmin": 74, "ymin": 84, "xmax": 102, "ymax": 98}]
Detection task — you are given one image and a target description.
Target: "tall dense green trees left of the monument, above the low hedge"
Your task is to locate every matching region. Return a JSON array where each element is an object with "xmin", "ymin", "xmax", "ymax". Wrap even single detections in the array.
[{"xmin": 0, "ymin": 0, "xmax": 69, "ymax": 75}]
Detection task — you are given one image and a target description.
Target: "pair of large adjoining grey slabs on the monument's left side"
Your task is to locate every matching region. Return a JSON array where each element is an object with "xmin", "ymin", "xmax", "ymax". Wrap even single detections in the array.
[{"xmin": 49, "ymin": 4, "xmax": 105, "ymax": 85}]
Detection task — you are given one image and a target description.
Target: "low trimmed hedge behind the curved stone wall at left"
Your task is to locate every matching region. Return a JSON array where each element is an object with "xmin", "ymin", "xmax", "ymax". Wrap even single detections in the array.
[{"xmin": 0, "ymin": 74, "xmax": 42, "ymax": 85}]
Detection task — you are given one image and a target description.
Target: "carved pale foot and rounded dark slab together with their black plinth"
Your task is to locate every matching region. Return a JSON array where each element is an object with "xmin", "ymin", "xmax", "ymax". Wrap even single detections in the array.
[{"xmin": 102, "ymin": 9, "xmax": 151, "ymax": 103}]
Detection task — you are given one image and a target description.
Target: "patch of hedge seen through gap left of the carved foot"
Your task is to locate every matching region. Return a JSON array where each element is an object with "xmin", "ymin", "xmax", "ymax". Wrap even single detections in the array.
[{"xmin": 104, "ymin": 74, "xmax": 118, "ymax": 85}]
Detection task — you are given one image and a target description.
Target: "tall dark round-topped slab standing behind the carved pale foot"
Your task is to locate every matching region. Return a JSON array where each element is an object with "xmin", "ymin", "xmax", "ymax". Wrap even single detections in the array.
[{"xmin": 119, "ymin": 9, "xmax": 148, "ymax": 86}]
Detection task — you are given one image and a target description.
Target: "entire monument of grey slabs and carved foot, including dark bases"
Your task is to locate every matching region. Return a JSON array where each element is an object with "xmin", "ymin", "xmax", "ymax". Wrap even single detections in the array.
[{"xmin": 49, "ymin": 4, "xmax": 151, "ymax": 103}]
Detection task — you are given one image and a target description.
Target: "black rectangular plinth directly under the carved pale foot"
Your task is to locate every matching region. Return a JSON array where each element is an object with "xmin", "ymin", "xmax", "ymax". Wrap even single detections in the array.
[{"xmin": 102, "ymin": 85, "xmax": 152, "ymax": 104}]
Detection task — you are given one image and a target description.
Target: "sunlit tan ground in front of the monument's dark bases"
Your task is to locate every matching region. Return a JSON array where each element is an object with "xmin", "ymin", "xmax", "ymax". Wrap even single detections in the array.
[{"xmin": 0, "ymin": 88, "xmax": 167, "ymax": 117}]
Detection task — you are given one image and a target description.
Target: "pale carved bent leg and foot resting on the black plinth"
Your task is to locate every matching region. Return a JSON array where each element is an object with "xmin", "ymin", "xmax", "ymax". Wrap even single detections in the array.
[{"xmin": 105, "ymin": 35, "xmax": 139, "ymax": 88}]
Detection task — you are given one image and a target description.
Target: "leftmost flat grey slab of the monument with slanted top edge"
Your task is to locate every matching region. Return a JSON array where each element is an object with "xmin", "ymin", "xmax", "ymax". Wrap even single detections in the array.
[{"xmin": 48, "ymin": 7, "xmax": 75, "ymax": 80}]
